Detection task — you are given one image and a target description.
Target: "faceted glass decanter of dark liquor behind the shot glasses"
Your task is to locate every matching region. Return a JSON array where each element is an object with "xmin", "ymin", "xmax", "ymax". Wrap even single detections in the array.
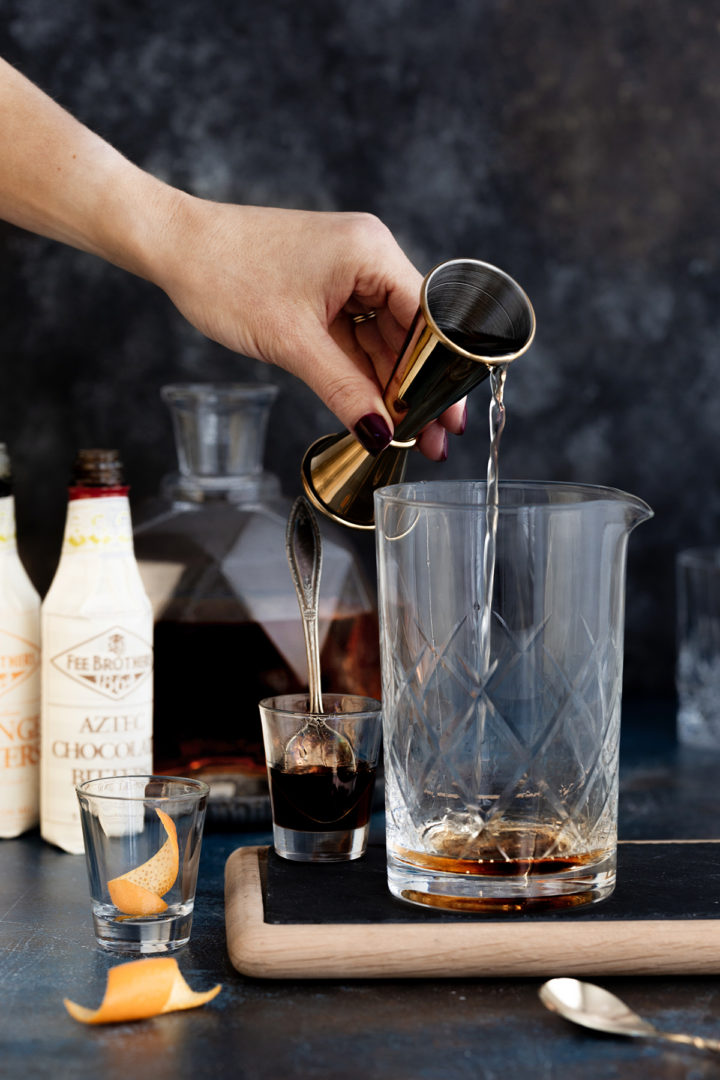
[{"xmin": 134, "ymin": 383, "xmax": 380, "ymax": 821}]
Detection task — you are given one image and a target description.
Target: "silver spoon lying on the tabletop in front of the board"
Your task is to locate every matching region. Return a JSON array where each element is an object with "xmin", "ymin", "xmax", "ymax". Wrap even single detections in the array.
[{"xmin": 538, "ymin": 978, "xmax": 720, "ymax": 1051}]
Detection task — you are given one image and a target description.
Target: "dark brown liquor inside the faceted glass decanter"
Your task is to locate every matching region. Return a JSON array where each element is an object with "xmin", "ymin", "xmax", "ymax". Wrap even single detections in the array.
[{"xmin": 154, "ymin": 612, "xmax": 380, "ymax": 781}]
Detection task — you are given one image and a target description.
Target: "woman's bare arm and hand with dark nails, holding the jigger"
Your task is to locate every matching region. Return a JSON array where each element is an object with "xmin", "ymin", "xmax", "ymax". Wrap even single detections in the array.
[{"xmin": 0, "ymin": 59, "xmax": 465, "ymax": 460}]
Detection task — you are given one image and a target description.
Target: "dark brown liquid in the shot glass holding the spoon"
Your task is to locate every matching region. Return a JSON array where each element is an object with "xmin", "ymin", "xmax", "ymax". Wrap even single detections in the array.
[{"xmin": 269, "ymin": 761, "xmax": 376, "ymax": 833}]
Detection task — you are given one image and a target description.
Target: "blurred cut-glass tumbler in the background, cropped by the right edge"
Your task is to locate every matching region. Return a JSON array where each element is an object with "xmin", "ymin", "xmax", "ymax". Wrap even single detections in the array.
[{"xmin": 676, "ymin": 548, "xmax": 720, "ymax": 751}]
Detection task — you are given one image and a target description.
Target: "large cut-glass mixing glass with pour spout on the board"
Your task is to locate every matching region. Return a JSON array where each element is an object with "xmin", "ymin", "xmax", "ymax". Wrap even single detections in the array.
[{"xmin": 375, "ymin": 481, "xmax": 652, "ymax": 910}]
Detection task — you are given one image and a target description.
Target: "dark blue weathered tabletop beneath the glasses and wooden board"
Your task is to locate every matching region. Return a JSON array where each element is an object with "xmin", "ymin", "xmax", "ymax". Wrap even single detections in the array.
[{"xmin": 0, "ymin": 705, "xmax": 720, "ymax": 1080}]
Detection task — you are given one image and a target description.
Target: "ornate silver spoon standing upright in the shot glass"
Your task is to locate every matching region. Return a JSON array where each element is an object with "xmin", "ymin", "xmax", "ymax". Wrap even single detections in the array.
[{"xmin": 285, "ymin": 495, "xmax": 355, "ymax": 769}]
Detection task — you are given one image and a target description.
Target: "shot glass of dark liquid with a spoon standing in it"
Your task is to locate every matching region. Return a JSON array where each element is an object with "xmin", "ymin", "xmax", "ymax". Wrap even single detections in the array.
[{"xmin": 259, "ymin": 693, "xmax": 382, "ymax": 863}]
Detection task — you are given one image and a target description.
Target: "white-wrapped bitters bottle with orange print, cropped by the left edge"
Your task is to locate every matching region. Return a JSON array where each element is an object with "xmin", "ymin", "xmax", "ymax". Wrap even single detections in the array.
[{"xmin": 0, "ymin": 443, "xmax": 40, "ymax": 838}]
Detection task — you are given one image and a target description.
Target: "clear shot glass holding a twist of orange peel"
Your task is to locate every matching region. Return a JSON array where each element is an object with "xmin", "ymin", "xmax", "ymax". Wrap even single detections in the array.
[{"xmin": 77, "ymin": 775, "xmax": 209, "ymax": 955}]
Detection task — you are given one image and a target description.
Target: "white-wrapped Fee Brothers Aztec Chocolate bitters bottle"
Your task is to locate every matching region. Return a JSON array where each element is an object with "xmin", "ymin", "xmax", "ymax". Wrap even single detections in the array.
[{"xmin": 40, "ymin": 449, "xmax": 152, "ymax": 853}]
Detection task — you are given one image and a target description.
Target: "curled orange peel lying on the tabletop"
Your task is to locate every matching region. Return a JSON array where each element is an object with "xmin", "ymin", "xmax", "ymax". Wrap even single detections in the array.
[{"xmin": 63, "ymin": 956, "xmax": 222, "ymax": 1024}]
